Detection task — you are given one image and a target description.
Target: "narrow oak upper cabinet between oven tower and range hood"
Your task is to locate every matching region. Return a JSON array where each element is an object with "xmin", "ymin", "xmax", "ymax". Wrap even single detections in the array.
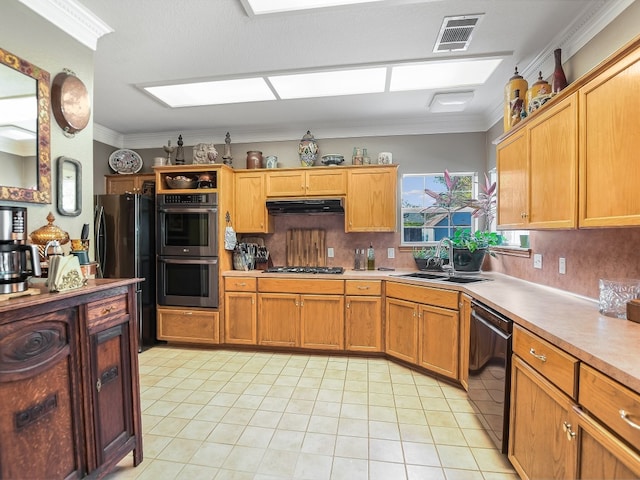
[{"xmin": 232, "ymin": 170, "xmax": 273, "ymax": 233}]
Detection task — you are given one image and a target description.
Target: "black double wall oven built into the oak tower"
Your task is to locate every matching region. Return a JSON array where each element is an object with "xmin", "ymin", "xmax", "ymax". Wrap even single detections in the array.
[{"xmin": 157, "ymin": 193, "xmax": 219, "ymax": 308}]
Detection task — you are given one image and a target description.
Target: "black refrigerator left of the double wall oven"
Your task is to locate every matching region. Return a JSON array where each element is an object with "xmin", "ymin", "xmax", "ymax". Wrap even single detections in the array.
[{"xmin": 94, "ymin": 193, "xmax": 157, "ymax": 351}]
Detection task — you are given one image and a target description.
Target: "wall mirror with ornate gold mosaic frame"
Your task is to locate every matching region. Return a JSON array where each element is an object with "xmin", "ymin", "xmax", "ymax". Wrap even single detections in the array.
[{"xmin": 0, "ymin": 48, "xmax": 51, "ymax": 203}]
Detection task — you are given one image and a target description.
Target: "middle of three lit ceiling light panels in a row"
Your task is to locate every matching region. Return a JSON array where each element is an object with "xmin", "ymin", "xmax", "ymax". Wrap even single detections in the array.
[{"xmin": 269, "ymin": 67, "xmax": 387, "ymax": 99}]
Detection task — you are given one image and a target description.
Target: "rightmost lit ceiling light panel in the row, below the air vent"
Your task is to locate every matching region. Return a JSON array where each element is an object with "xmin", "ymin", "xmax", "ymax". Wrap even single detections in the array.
[{"xmin": 389, "ymin": 58, "xmax": 502, "ymax": 92}]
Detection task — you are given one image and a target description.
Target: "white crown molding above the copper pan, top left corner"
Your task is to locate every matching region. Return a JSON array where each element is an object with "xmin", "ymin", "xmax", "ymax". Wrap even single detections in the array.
[{"xmin": 18, "ymin": 0, "xmax": 113, "ymax": 51}]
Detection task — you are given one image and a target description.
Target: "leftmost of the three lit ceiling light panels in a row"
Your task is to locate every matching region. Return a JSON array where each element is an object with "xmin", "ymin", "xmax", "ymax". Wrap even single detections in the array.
[{"xmin": 144, "ymin": 77, "xmax": 276, "ymax": 108}]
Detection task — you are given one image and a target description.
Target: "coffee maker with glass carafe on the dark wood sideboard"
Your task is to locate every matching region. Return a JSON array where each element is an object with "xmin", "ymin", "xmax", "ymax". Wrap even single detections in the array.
[{"xmin": 0, "ymin": 205, "xmax": 42, "ymax": 294}]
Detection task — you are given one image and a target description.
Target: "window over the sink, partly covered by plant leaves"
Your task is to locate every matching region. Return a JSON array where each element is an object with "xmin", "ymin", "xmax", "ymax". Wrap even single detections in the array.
[{"xmin": 401, "ymin": 172, "xmax": 477, "ymax": 246}]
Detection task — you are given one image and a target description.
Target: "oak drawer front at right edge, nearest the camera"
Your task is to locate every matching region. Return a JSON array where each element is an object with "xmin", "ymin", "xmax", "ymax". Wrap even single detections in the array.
[{"xmin": 578, "ymin": 364, "xmax": 640, "ymax": 450}]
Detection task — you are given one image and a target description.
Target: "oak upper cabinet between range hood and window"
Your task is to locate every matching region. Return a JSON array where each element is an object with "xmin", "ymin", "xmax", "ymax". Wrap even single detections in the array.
[{"xmin": 345, "ymin": 165, "xmax": 398, "ymax": 232}]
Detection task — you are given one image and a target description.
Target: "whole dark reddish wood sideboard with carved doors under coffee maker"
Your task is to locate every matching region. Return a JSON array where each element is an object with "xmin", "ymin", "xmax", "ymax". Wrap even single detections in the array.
[{"xmin": 0, "ymin": 280, "xmax": 142, "ymax": 480}]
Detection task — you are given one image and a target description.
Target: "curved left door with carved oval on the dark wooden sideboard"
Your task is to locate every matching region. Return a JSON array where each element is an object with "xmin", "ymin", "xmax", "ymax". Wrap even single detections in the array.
[{"xmin": 0, "ymin": 308, "xmax": 87, "ymax": 478}]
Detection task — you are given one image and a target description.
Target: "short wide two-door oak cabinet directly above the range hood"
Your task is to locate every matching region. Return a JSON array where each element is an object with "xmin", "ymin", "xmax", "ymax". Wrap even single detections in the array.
[{"xmin": 266, "ymin": 167, "xmax": 347, "ymax": 197}]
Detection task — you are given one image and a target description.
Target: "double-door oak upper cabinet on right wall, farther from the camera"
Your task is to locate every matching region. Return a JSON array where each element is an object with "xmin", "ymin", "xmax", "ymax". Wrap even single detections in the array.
[{"xmin": 497, "ymin": 94, "xmax": 578, "ymax": 229}]
